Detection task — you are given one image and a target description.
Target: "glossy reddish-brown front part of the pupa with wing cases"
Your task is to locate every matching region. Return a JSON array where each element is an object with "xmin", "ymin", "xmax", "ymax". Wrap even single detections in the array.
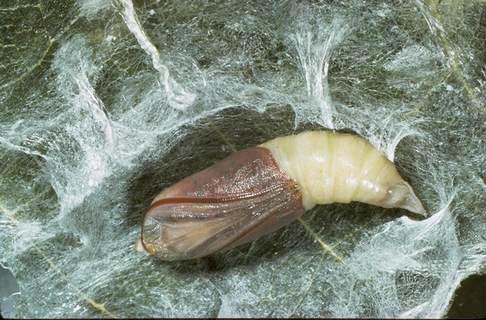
[{"xmin": 142, "ymin": 147, "xmax": 304, "ymax": 260}]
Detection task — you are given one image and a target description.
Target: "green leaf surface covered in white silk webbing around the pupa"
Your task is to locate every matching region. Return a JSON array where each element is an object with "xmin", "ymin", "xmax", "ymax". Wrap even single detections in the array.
[{"xmin": 0, "ymin": 0, "xmax": 486, "ymax": 318}]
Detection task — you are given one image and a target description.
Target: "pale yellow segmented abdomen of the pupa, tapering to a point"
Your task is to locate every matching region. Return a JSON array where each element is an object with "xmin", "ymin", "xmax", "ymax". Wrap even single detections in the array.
[{"xmin": 260, "ymin": 131, "xmax": 424, "ymax": 213}]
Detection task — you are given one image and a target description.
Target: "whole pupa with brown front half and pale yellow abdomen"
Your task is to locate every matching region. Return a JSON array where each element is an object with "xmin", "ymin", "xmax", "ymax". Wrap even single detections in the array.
[{"xmin": 141, "ymin": 131, "xmax": 426, "ymax": 260}]
